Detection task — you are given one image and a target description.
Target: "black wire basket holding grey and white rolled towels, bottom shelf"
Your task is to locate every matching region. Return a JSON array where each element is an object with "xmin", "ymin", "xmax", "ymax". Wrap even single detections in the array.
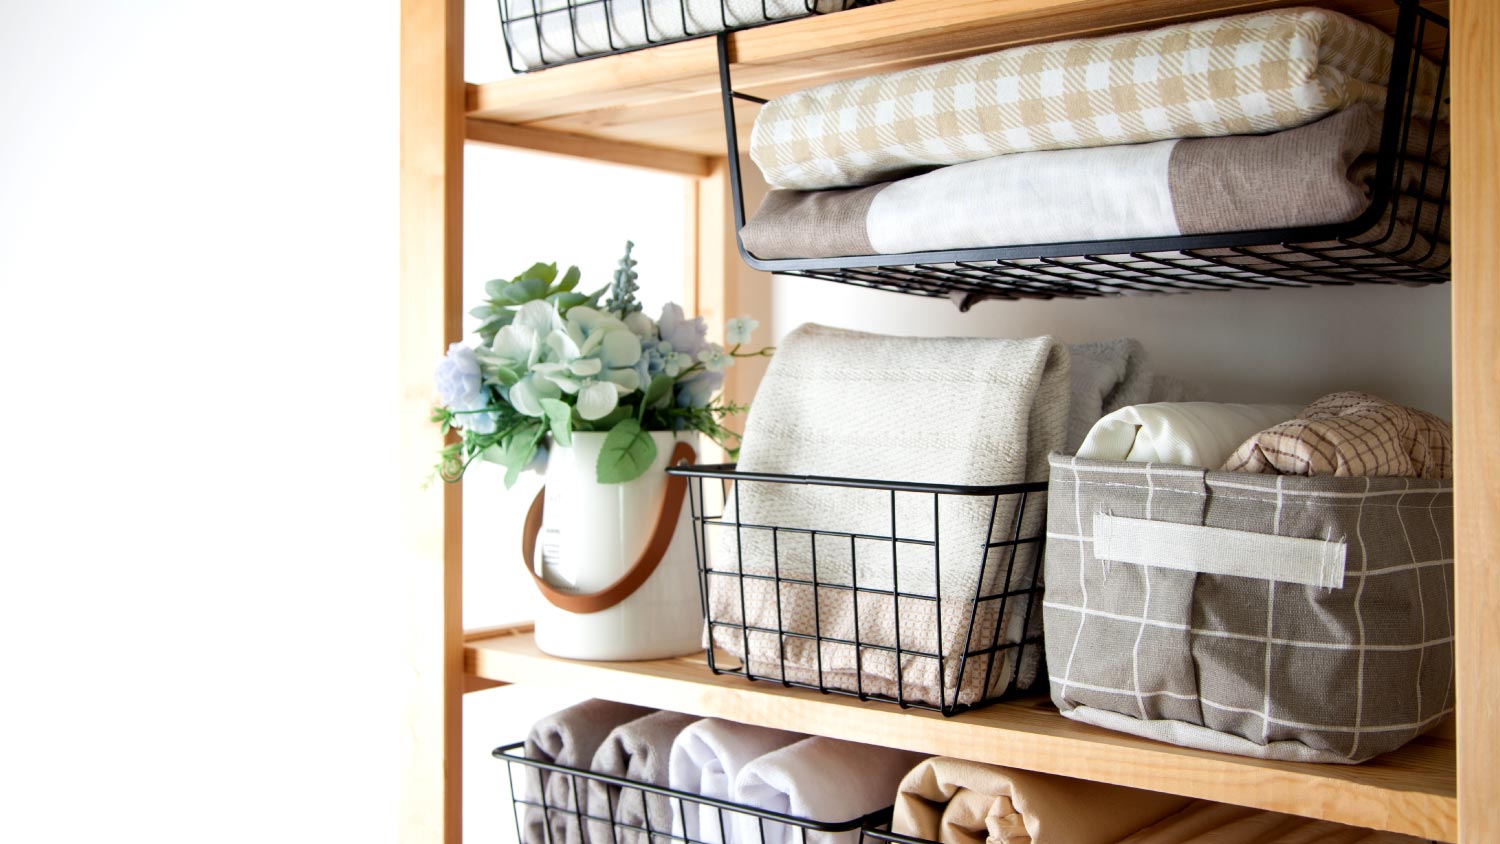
[{"xmin": 494, "ymin": 742, "xmax": 888, "ymax": 844}]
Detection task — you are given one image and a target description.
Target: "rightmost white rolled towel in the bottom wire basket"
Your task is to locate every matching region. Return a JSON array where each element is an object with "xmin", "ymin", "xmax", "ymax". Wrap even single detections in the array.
[{"xmin": 735, "ymin": 736, "xmax": 923, "ymax": 844}]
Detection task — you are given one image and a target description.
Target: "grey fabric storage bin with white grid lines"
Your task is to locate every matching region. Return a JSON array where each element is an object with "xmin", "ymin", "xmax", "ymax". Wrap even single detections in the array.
[{"xmin": 1043, "ymin": 454, "xmax": 1454, "ymax": 763}]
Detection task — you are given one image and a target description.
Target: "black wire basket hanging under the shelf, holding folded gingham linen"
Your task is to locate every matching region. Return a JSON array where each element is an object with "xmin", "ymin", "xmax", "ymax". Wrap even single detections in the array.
[{"xmin": 719, "ymin": 0, "xmax": 1452, "ymax": 310}]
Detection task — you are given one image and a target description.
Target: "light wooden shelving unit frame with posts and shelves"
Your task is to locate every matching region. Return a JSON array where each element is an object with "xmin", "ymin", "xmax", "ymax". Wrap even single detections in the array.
[{"xmin": 399, "ymin": 0, "xmax": 1500, "ymax": 844}]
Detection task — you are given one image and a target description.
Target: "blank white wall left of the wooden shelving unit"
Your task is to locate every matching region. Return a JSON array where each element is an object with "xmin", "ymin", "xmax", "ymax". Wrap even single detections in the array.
[{"xmin": 0, "ymin": 0, "xmax": 401, "ymax": 844}]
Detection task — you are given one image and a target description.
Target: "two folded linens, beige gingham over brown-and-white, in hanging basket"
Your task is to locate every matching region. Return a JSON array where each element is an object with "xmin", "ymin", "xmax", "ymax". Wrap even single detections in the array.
[{"xmin": 741, "ymin": 9, "xmax": 1449, "ymax": 267}]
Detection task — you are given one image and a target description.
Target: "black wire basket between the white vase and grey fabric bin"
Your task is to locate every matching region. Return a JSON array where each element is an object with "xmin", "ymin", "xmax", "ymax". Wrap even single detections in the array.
[{"xmin": 668, "ymin": 465, "xmax": 1047, "ymax": 715}]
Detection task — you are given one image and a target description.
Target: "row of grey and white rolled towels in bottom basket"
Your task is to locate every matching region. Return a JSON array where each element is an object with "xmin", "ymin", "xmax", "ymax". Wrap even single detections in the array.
[{"xmin": 521, "ymin": 700, "xmax": 923, "ymax": 844}]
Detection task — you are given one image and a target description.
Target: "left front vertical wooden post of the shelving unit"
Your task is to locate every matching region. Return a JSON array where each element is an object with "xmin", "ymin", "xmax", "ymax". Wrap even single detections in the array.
[{"xmin": 399, "ymin": 0, "xmax": 465, "ymax": 844}]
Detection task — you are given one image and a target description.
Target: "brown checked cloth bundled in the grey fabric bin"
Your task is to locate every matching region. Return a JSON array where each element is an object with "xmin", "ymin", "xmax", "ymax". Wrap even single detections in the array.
[{"xmin": 1223, "ymin": 393, "xmax": 1454, "ymax": 480}]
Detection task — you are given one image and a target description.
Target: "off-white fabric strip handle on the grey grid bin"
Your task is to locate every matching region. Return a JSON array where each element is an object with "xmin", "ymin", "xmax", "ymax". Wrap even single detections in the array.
[{"xmin": 1094, "ymin": 513, "xmax": 1349, "ymax": 589}]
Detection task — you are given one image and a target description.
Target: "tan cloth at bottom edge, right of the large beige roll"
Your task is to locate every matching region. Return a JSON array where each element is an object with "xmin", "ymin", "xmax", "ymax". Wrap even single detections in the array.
[{"xmin": 1119, "ymin": 801, "xmax": 1425, "ymax": 844}]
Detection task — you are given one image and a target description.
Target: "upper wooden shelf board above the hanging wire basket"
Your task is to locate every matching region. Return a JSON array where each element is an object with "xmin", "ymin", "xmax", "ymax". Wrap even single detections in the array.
[{"xmin": 468, "ymin": 0, "xmax": 1448, "ymax": 160}]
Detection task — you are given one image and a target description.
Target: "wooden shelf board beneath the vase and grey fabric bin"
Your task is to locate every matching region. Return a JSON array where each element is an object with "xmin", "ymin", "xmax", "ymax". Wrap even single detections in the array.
[{"xmin": 465, "ymin": 631, "xmax": 1458, "ymax": 841}]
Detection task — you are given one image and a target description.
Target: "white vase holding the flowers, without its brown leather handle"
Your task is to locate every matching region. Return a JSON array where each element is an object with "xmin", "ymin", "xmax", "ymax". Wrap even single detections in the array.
[{"xmin": 528, "ymin": 432, "xmax": 704, "ymax": 660}]
